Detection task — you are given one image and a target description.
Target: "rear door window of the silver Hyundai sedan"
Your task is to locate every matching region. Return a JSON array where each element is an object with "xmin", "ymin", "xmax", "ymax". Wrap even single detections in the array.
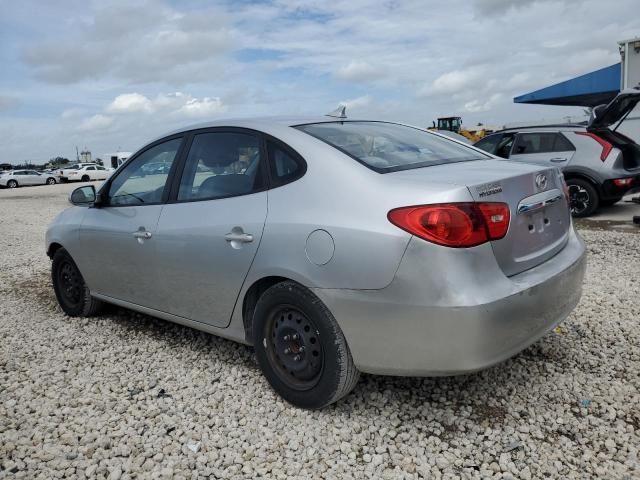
[{"xmin": 178, "ymin": 132, "xmax": 263, "ymax": 201}]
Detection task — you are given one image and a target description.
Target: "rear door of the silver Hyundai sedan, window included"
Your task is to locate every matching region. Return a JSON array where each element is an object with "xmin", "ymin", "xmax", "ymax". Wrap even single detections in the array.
[{"xmin": 156, "ymin": 129, "xmax": 267, "ymax": 327}]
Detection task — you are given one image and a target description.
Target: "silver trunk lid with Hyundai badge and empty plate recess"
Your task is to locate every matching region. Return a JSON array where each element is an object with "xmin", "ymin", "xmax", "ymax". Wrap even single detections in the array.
[{"xmin": 393, "ymin": 160, "xmax": 571, "ymax": 276}]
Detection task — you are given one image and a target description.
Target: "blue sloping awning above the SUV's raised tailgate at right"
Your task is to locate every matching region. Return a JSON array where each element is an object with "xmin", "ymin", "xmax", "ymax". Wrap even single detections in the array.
[{"xmin": 513, "ymin": 63, "xmax": 621, "ymax": 107}]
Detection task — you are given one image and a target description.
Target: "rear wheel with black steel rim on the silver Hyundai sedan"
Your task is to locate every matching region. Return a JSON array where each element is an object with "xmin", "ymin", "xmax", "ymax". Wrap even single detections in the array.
[{"xmin": 252, "ymin": 281, "xmax": 360, "ymax": 409}]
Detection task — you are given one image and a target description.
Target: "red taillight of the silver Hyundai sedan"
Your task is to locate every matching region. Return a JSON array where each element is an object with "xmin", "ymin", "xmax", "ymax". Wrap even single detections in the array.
[{"xmin": 387, "ymin": 202, "xmax": 509, "ymax": 248}]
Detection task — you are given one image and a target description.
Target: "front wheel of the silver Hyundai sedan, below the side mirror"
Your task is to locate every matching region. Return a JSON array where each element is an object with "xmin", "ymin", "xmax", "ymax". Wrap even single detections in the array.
[{"xmin": 51, "ymin": 248, "xmax": 103, "ymax": 317}]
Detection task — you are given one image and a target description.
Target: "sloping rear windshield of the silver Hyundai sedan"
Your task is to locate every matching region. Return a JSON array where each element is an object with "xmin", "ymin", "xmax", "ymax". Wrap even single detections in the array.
[{"xmin": 296, "ymin": 121, "xmax": 490, "ymax": 173}]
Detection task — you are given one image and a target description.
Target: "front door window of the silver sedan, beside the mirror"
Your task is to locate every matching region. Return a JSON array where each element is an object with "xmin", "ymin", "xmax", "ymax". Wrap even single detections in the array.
[{"xmin": 108, "ymin": 138, "xmax": 182, "ymax": 205}]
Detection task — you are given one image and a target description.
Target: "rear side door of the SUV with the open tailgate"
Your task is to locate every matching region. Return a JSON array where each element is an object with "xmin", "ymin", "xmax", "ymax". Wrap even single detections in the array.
[{"xmin": 509, "ymin": 132, "xmax": 575, "ymax": 167}]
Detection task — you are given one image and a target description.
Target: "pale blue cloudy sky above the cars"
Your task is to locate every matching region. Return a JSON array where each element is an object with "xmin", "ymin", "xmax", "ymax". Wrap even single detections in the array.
[{"xmin": 0, "ymin": 0, "xmax": 640, "ymax": 163}]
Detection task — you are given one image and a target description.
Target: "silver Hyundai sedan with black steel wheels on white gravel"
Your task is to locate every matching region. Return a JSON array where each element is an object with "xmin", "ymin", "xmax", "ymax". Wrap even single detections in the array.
[{"xmin": 46, "ymin": 112, "xmax": 586, "ymax": 408}]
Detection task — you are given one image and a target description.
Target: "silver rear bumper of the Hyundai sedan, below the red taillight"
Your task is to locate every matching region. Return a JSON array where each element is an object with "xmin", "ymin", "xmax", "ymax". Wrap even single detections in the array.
[{"xmin": 314, "ymin": 231, "xmax": 586, "ymax": 376}]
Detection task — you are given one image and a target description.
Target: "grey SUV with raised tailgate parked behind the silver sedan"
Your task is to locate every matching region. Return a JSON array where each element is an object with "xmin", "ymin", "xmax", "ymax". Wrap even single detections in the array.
[{"xmin": 475, "ymin": 89, "xmax": 640, "ymax": 217}]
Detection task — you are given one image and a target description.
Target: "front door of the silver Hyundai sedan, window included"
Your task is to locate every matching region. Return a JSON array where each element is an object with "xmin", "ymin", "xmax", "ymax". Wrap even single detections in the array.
[{"xmin": 76, "ymin": 136, "xmax": 182, "ymax": 307}]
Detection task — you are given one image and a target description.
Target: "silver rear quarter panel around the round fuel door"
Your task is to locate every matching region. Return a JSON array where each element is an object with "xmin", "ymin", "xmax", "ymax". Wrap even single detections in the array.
[{"xmin": 246, "ymin": 128, "xmax": 470, "ymax": 290}]
